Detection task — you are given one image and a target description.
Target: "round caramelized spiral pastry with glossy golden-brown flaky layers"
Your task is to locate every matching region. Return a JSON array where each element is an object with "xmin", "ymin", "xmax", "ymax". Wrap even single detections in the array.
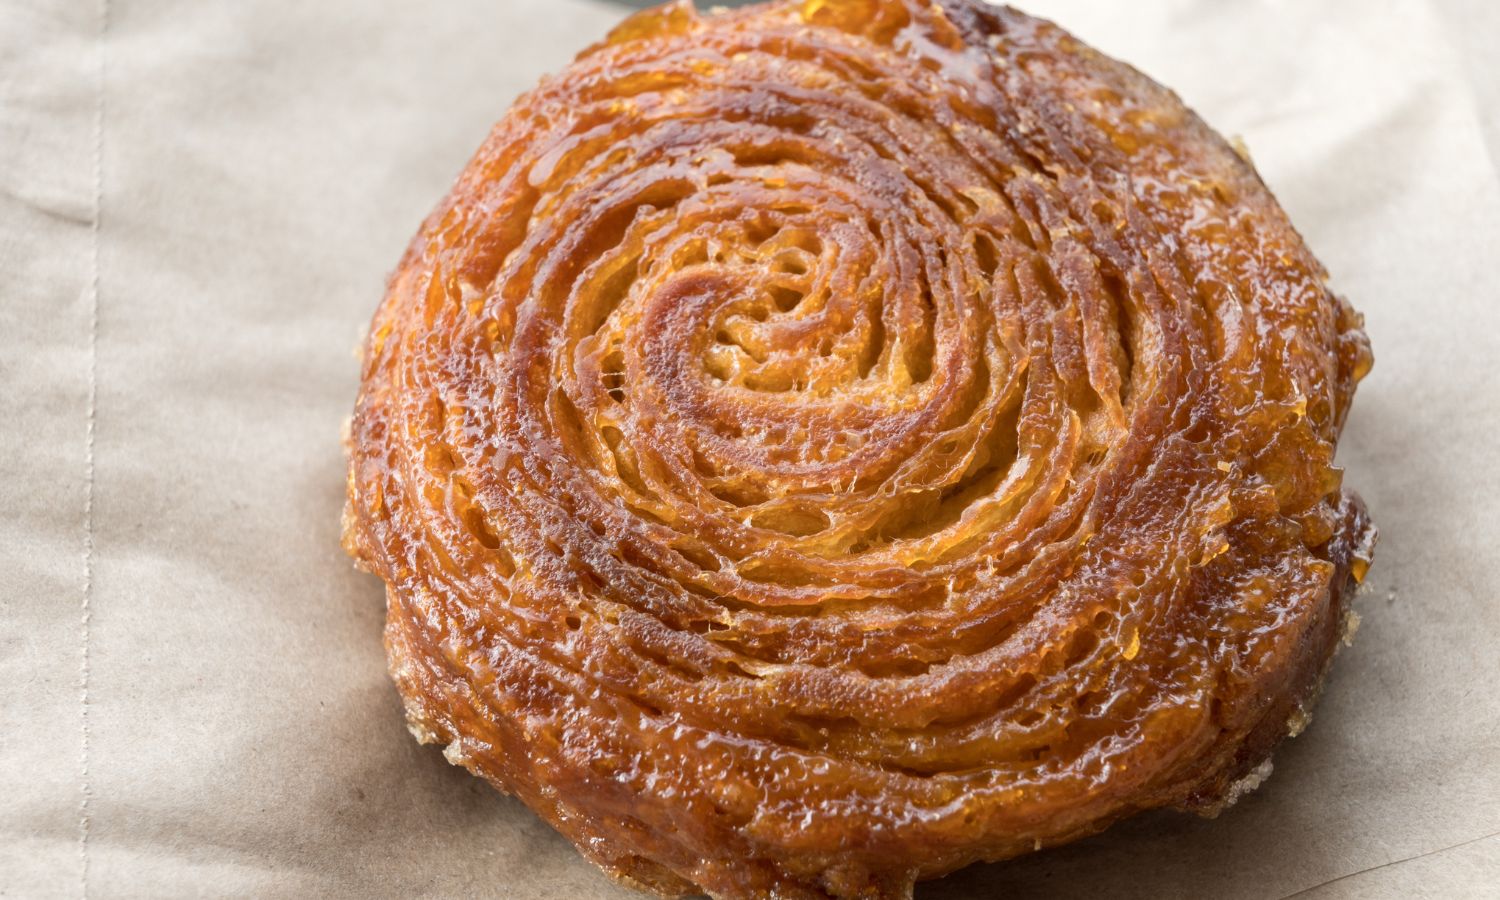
[{"xmin": 345, "ymin": 0, "xmax": 1374, "ymax": 899}]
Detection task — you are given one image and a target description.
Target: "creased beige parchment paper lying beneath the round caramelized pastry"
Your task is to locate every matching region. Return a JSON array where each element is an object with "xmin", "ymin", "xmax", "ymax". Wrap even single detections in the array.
[{"xmin": 0, "ymin": 0, "xmax": 1500, "ymax": 900}]
